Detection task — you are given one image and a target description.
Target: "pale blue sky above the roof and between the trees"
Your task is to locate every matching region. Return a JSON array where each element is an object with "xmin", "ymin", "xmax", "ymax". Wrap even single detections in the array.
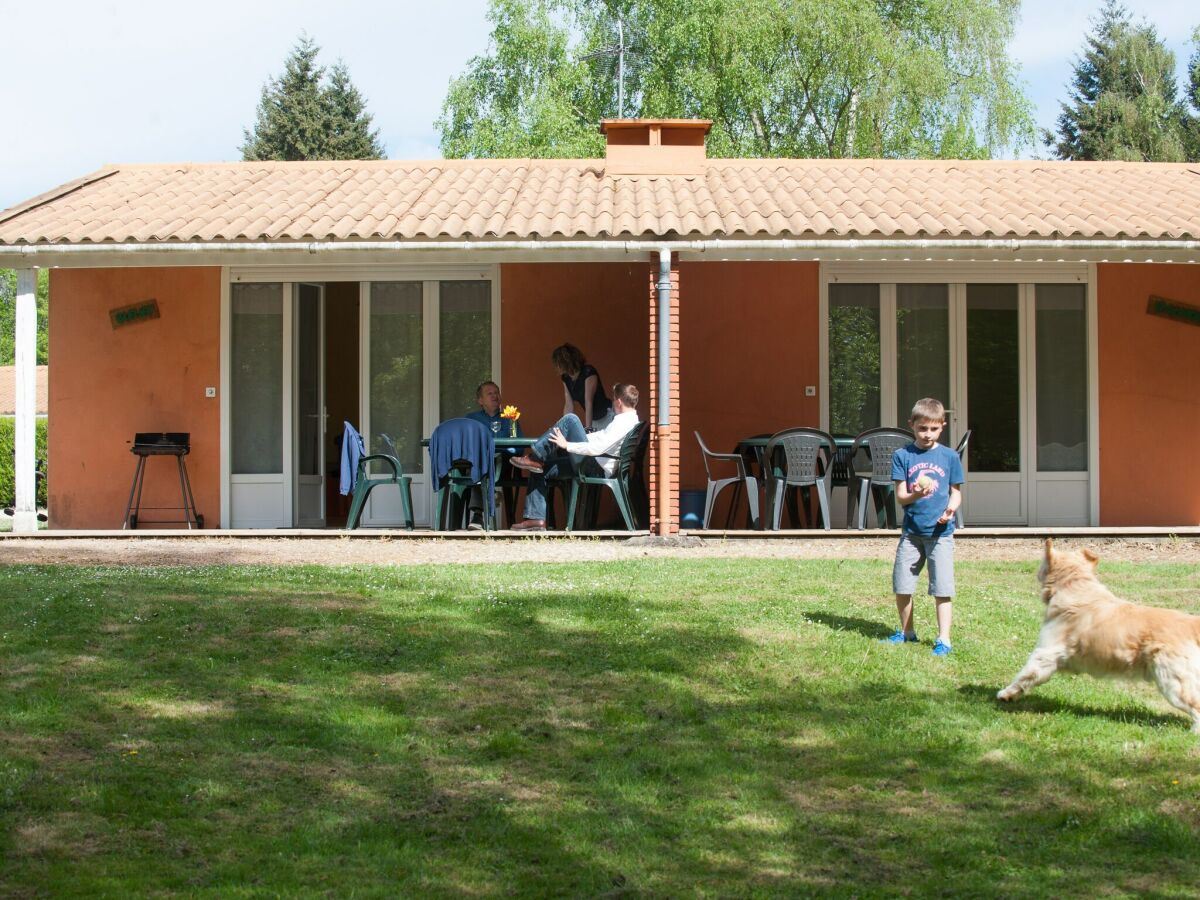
[{"xmin": 0, "ymin": 0, "xmax": 1200, "ymax": 209}]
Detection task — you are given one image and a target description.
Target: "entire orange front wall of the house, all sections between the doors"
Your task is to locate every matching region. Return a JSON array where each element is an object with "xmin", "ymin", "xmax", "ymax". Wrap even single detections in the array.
[{"xmin": 49, "ymin": 262, "xmax": 1200, "ymax": 528}]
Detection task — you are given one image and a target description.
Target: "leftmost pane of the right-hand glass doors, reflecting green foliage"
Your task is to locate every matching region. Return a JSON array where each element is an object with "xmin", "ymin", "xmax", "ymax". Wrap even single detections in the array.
[{"xmin": 828, "ymin": 284, "xmax": 880, "ymax": 434}]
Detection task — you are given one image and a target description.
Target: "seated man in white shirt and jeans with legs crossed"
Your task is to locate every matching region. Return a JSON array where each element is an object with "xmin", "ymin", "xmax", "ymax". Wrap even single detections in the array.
[{"xmin": 511, "ymin": 384, "xmax": 637, "ymax": 532}]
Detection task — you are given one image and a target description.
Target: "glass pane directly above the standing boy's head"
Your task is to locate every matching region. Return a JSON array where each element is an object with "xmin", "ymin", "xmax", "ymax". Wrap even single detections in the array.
[{"xmin": 896, "ymin": 284, "xmax": 950, "ymax": 444}]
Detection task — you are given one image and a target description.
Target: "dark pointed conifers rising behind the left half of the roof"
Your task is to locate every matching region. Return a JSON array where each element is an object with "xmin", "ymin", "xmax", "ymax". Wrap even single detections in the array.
[{"xmin": 241, "ymin": 36, "xmax": 384, "ymax": 160}]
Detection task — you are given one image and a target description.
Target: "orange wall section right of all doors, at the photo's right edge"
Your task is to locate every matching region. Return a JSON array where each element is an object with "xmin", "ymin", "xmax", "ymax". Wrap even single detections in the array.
[{"xmin": 1097, "ymin": 264, "xmax": 1200, "ymax": 526}]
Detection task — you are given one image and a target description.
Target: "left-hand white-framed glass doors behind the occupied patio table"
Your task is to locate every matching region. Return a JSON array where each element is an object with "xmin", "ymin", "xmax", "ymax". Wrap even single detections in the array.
[{"xmin": 222, "ymin": 269, "xmax": 499, "ymax": 528}]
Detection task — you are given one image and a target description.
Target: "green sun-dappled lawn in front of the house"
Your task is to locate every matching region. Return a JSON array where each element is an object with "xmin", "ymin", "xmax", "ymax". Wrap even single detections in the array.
[{"xmin": 0, "ymin": 560, "xmax": 1200, "ymax": 898}]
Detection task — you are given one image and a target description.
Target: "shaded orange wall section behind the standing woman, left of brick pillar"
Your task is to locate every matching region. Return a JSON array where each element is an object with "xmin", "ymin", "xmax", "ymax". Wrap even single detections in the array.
[{"xmin": 498, "ymin": 263, "xmax": 649, "ymax": 436}]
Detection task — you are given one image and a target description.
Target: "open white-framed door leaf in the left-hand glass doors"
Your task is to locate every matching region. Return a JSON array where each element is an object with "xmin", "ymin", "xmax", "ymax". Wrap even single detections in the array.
[{"xmin": 293, "ymin": 283, "xmax": 325, "ymax": 528}]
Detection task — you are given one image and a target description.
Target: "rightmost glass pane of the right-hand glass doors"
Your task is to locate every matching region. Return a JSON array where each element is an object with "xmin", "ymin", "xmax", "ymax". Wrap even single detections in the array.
[{"xmin": 1034, "ymin": 284, "xmax": 1087, "ymax": 472}]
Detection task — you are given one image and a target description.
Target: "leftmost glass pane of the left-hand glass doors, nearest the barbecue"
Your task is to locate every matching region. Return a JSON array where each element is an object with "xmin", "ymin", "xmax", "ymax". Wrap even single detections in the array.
[{"xmin": 229, "ymin": 284, "xmax": 283, "ymax": 475}]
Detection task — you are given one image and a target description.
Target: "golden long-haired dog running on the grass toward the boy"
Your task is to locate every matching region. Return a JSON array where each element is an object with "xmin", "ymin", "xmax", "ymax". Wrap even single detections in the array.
[{"xmin": 996, "ymin": 539, "xmax": 1200, "ymax": 734}]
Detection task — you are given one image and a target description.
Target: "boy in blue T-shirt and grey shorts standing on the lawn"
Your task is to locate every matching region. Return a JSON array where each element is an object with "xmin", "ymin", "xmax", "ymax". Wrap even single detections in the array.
[{"xmin": 887, "ymin": 397, "xmax": 962, "ymax": 656}]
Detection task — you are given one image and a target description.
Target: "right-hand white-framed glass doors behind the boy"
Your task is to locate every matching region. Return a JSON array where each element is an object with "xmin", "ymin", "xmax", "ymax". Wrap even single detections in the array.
[{"xmin": 824, "ymin": 277, "xmax": 1091, "ymax": 526}]
